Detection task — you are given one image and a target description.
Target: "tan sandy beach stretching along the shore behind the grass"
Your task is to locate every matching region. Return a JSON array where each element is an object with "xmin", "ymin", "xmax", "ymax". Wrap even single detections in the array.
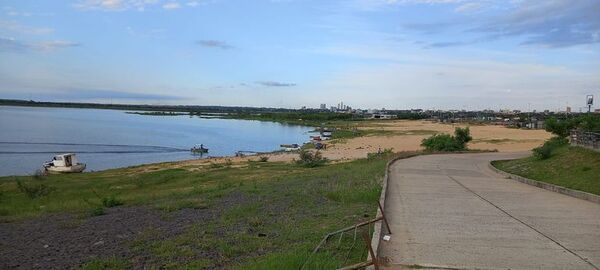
[{"xmin": 149, "ymin": 120, "xmax": 552, "ymax": 170}]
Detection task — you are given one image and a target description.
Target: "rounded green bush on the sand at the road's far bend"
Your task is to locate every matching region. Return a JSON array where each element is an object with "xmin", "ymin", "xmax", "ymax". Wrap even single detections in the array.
[{"xmin": 421, "ymin": 127, "xmax": 473, "ymax": 152}]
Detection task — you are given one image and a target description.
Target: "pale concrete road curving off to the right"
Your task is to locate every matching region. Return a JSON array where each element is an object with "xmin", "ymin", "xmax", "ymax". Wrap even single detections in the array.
[{"xmin": 380, "ymin": 153, "xmax": 600, "ymax": 269}]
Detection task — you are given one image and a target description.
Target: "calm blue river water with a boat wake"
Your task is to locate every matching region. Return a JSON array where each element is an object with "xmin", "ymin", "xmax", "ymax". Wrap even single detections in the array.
[{"xmin": 0, "ymin": 106, "xmax": 311, "ymax": 176}]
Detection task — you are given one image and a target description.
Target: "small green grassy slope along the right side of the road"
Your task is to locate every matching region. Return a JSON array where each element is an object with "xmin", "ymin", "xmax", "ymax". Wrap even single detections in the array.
[{"xmin": 493, "ymin": 146, "xmax": 600, "ymax": 195}]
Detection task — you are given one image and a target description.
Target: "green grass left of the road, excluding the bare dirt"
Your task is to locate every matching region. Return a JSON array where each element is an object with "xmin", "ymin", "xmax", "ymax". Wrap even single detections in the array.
[{"xmin": 0, "ymin": 153, "xmax": 406, "ymax": 269}]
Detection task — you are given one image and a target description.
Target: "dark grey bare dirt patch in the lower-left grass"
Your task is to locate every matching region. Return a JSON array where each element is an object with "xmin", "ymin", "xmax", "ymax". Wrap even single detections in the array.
[{"xmin": 0, "ymin": 193, "xmax": 248, "ymax": 269}]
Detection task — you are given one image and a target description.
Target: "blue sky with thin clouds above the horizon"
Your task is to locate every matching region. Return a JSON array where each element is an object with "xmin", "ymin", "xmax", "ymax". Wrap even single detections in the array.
[{"xmin": 0, "ymin": 0, "xmax": 600, "ymax": 111}]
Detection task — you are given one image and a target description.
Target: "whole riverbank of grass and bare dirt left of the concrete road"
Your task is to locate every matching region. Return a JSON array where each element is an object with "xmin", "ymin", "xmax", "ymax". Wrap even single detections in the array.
[{"xmin": 0, "ymin": 153, "xmax": 398, "ymax": 269}]
